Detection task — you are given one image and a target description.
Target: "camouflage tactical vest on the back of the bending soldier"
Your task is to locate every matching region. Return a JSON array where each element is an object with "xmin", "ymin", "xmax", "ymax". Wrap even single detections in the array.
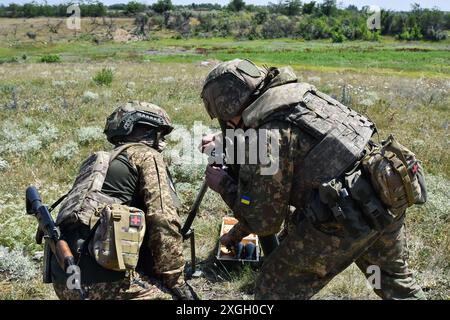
[{"xmin": 242, "ymin": 82, "xmax": 375, "ymax": 189}]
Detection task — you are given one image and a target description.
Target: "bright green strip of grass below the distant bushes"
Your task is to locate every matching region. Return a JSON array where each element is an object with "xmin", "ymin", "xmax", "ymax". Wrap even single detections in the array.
[{"xmin": 0, "ymin": 38, "xmax": 450, "ymax": 77}]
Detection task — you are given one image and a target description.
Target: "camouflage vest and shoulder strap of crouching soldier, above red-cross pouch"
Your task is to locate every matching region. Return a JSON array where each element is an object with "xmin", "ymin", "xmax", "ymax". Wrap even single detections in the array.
[{"xmin": 56, "ymin": 143, "xmax": 146, "ymax": 228}]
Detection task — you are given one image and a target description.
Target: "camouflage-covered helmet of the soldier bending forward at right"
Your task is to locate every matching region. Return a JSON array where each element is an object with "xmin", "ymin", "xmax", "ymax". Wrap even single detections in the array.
[{"xmin": 202, "ymin": 59, "xmax": 267, "ymax": 121}]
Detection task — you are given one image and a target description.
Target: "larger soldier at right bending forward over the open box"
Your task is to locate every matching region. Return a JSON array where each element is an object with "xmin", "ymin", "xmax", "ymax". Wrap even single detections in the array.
[{"xmin": 202, "ymin": 59, "xmax": 426, "ymax": 299}]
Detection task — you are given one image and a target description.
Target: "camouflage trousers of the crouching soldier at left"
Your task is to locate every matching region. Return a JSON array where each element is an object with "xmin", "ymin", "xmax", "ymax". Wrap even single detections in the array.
[{"xmin": 53, "ymin": 277, "xmax": 173, "ymax": 300}]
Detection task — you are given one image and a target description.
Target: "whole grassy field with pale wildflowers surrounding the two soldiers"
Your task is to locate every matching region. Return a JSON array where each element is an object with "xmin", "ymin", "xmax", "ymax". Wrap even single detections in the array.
[{"xmin": 0, "ymin": 19, "xmax": 450, "ymax": 299}]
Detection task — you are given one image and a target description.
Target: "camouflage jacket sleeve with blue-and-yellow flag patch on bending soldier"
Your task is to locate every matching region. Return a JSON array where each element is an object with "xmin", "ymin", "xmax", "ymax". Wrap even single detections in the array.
[{"xmin": 221, "ymin": 121, "xmax": 304, "ymax": 238}]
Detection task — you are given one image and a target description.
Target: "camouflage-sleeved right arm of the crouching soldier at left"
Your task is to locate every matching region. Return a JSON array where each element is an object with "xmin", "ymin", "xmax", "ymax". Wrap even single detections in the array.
[{"xmin": 132, "ymin": 151, "xmax": 184, "ymax": 288}]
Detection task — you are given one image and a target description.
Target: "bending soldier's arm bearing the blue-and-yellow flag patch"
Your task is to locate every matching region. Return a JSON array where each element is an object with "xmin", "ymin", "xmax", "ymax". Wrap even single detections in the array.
[{"xmin": 230, "ymin": 122, "xmax": 294, "ymax": 238}]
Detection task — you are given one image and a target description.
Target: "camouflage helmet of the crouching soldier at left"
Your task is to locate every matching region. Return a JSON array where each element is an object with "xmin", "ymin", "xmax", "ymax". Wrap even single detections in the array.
[{"xmin": 103, "ymin": 101, "xmax": 173, "ymax": 144}]
